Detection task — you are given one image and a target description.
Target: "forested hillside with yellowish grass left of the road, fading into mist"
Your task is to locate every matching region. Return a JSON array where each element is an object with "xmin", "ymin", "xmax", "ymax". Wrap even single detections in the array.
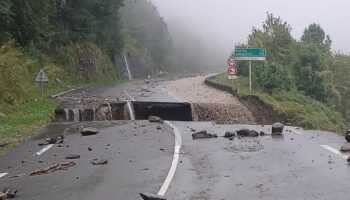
[{"xmin": 0, "ymin": 0, "xmax": 176, "ymax": 113}]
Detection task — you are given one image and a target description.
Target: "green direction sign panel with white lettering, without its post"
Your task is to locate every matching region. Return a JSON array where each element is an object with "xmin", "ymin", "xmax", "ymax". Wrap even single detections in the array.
[{"xmin": 232, "ymin": 48, "xmax": 266, "ymax": 60}]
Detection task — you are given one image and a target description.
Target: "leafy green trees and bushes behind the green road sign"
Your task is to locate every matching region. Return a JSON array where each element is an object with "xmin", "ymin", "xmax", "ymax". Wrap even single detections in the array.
[{"xmin": 237, "ymin": 13, "xmax": 350, "ymax": 129}]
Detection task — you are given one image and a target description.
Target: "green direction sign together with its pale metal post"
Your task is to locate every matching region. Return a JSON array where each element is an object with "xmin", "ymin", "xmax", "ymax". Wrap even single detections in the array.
[{"xmin": 232, "ymin": 48, "xmax": 266, "ymax": 92}]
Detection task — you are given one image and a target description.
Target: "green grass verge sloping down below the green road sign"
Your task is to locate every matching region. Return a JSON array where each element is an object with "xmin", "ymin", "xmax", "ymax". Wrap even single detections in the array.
[{"xmin": 212, "ymin": 74, "xmax": 346, "ymax": 133}]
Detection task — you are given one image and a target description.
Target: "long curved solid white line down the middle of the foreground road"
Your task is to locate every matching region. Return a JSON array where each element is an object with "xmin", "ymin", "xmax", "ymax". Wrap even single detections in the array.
[{"xmin": 157, "ymin": 121, "xmax": 182, "ymax": 196}]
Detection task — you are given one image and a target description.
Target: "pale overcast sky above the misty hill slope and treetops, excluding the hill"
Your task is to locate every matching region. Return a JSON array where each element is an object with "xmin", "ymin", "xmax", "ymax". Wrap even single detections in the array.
[{"xmin": 151, "ymin": 0, "xmax": 350, "ymax": 56}]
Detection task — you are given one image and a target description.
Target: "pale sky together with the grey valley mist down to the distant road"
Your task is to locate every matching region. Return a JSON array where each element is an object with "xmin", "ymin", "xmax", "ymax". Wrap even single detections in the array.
[{"xmin": 151, "ymin": 0, "xmax": 350, "ymax": 72}]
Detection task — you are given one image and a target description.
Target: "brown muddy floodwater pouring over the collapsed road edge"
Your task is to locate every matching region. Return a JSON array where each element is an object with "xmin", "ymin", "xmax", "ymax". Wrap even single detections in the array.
[{"xmin": 166, "ymin": 76, "xmax": 255, "ymax": 124}]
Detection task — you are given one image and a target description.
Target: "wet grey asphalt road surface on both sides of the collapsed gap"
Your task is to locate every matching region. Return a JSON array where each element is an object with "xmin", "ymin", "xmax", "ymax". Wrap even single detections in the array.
[{"xmin": 0, "ymin": 79, "xmax": 350, "ymax": 200}]
